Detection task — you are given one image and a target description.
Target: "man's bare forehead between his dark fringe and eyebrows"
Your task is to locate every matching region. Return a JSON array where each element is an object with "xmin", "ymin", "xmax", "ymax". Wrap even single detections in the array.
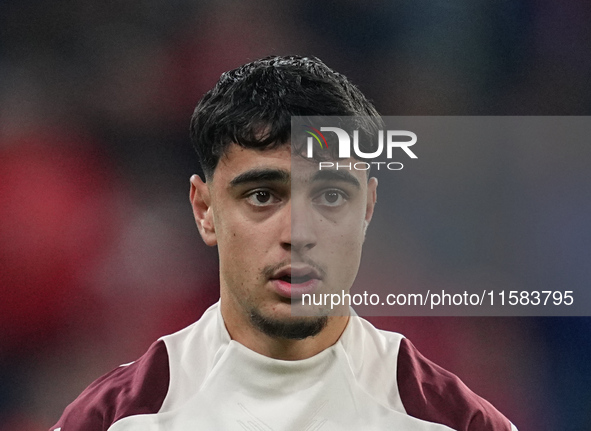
[{"xmin": 213, "ymin": 143, "xmax": 367, "ymax": 184}]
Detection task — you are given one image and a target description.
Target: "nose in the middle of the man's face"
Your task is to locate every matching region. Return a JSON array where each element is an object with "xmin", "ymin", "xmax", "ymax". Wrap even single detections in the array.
[{"xmin": 282, "ymin": 200, "xmax": 317, "ymax": 253}]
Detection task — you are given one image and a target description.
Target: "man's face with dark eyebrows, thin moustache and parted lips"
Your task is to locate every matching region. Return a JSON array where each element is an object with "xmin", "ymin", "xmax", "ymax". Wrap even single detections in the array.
[{"xmin": 191, "ymin": 144, "xmax": 377, "ymax": 340}]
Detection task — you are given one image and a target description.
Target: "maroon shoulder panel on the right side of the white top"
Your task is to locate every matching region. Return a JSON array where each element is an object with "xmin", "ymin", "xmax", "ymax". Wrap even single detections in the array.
[{"xmin": 396, "ymin": 338, "xmax": 512, "ymax": 431}]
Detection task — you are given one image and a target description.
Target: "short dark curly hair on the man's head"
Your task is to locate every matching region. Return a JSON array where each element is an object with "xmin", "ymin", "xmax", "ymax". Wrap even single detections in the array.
[{"xmin": 191, "ymin": 56, "xmax": 378, "ymax": 179}]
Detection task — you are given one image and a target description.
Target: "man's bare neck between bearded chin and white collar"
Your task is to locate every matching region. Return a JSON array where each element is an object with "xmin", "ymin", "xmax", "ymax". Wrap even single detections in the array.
[{"xmin": 221, "ymin": 297, "xmax": 349, "ymax": 361}]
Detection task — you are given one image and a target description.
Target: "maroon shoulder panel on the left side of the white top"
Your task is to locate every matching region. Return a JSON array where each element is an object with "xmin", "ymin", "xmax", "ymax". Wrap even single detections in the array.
[{"xmin": 51, "ymin": 340, "xmax": 170, "ymax": 431}]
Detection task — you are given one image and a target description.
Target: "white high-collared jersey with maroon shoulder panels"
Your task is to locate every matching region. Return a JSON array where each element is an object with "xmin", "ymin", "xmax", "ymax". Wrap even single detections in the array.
[{"xmin": 51, "ymin": 303, "xmax": 515, "ymax": 431}]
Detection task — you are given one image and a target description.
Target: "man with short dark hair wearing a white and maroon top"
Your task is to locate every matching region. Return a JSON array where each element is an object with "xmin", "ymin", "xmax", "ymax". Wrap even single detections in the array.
[{"xmin": 52, "ymin": 57, "xmax": 515, "ymax": 431}]
